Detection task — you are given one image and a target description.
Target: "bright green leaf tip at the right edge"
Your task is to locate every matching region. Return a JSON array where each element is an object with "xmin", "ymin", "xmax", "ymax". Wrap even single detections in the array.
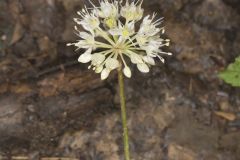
[{"xmin": 219, "ymin": 56, "xmax": 240, "ymax": 87}]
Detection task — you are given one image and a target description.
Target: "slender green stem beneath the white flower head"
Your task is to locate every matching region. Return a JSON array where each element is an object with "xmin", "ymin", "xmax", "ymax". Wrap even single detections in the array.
[{"xmin": 118, "ymin": 67, "xmax": 130, "ymax": 160}]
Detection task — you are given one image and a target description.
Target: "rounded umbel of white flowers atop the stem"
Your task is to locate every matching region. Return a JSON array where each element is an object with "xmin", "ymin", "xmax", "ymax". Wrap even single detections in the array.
[{"xmin": 67, "ymin": 0, "xmax": 172, "ymax": 80}]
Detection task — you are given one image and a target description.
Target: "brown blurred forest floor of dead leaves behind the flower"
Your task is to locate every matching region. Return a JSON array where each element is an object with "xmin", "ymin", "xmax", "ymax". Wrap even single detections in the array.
[{"xmin": 0, "ymin": 0, "xmax": 240, "ymax": 160}]
